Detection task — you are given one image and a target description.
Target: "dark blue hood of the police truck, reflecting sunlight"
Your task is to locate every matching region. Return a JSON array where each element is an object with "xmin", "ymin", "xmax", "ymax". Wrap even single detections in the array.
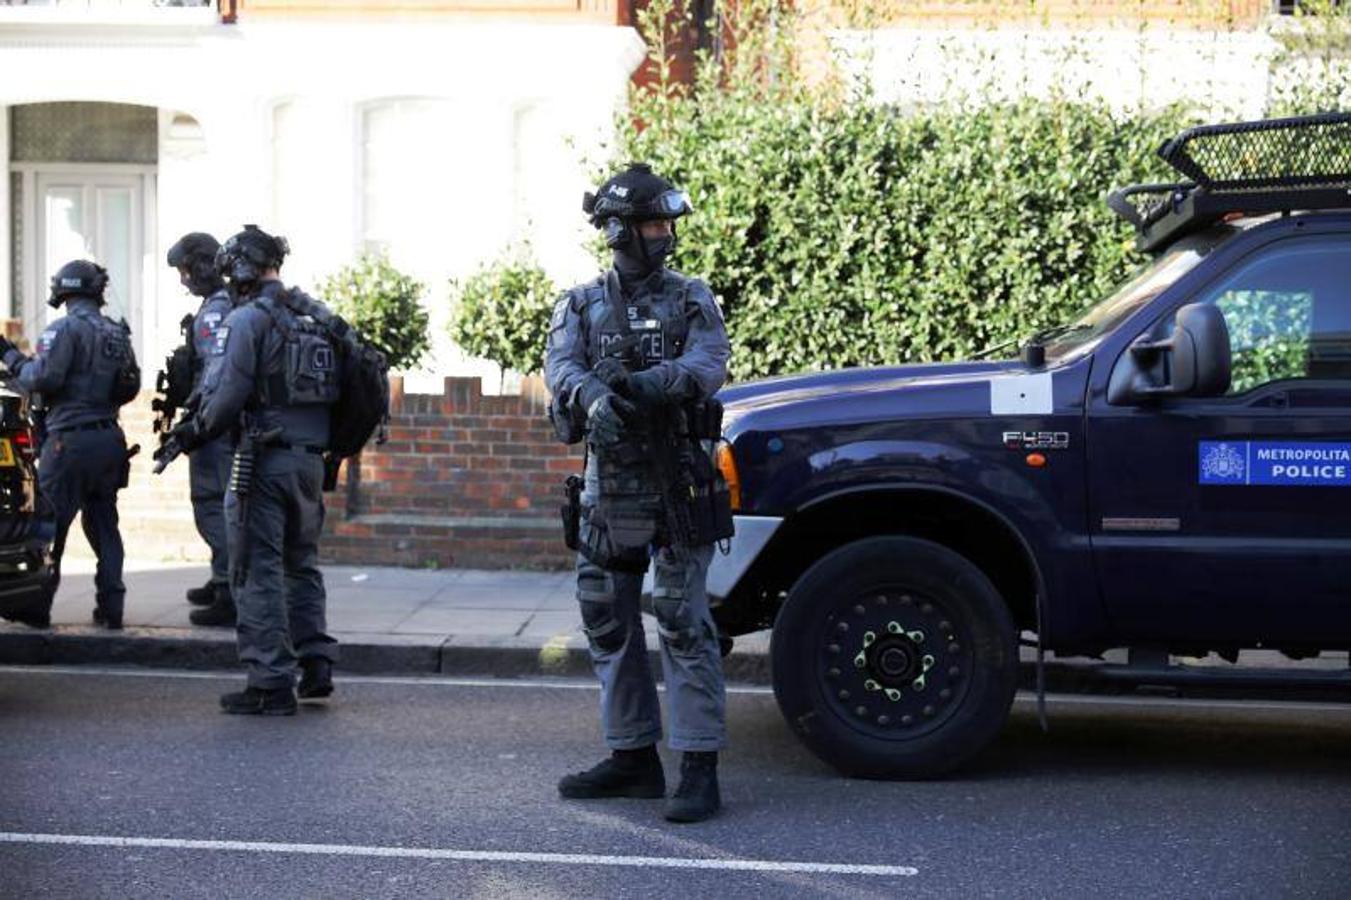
[{"xmin": 717, "ymin": 359, "xmax": 1028, "ymax": 438}]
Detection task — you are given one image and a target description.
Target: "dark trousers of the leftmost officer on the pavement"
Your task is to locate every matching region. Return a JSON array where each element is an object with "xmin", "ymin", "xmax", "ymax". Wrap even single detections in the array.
[{"xmin": 38, "ymin": 426, "xmax": 127, "ymax": 618}]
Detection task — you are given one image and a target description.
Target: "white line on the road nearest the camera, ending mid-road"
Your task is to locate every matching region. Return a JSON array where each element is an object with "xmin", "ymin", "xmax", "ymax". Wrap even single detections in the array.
[{"xmin": 0, "ymin": 831, "xmax": 920, "ymax": 877}]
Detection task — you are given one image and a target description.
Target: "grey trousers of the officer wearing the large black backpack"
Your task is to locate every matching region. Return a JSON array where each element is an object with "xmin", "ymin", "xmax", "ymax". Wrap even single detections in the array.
[{"xmin": 226, "ymin": 449, "xmax": 338, "ymax": 689}]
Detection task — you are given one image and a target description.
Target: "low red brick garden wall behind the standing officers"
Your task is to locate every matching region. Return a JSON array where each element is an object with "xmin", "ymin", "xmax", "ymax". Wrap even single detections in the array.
[{"xmin": 69, "ymin": 378, "xmax": 581, "ymax": 569}]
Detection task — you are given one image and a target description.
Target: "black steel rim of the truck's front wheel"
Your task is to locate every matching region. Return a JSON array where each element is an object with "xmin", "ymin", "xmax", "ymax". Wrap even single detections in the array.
[{"xmin": 816, "ymin": 586, "xmax": 975, "ymax": 741}]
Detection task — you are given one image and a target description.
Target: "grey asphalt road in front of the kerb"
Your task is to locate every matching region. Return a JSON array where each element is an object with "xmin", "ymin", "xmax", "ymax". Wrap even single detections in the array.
[{"xmin": 0, "ymin": 668, "xmax": 1351, "ymax": 899}]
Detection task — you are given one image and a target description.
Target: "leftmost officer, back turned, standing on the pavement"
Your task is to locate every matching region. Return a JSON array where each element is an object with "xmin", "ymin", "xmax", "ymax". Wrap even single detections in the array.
[{"xmin": 0, "ymin": 259, "xmax": 141, "ymax": 630}]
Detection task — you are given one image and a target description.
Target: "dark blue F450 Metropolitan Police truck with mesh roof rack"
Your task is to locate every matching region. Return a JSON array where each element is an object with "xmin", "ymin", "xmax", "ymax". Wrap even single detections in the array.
[{"xmin": 709, "ymin": 114, "xmax": 1351, "ymax": 777}]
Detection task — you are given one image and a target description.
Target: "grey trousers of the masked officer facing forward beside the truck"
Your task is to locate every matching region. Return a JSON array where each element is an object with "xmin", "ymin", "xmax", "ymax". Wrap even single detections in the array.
[{"xmin": 577, "ymin": 546, "xmax": 727, "ymax": 750}]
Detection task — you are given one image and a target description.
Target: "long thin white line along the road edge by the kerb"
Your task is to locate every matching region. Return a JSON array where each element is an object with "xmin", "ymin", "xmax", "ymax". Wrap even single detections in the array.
[{"xmin": 0, "ymin": 665, "xmax": 1351, "ymax": 712}]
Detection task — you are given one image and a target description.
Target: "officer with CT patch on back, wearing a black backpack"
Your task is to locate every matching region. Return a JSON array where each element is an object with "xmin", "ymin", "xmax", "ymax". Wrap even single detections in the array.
[{"xmin": 174, "ymin": 226, "xmax": 339, "ymax": 715}]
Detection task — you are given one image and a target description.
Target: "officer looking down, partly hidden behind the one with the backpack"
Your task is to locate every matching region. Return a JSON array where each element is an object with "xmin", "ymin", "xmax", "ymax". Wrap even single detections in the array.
[{"xmin": 168, "ymin": 231, "xmax": 235, "ymax": 626}]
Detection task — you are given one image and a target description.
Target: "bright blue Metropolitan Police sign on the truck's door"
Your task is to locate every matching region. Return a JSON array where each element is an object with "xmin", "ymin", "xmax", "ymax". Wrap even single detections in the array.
[{"xmin": 1197, "ymin": 441, "xmax": 1351, "ymax": 488}]
